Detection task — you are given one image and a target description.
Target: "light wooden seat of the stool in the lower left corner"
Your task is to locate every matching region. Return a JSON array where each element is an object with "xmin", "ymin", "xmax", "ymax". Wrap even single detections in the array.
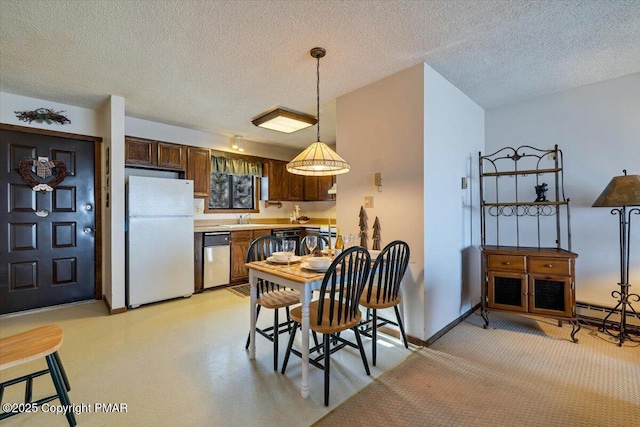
[{"xmin": 0, "ymin": 325, "xmax": 63, "ymax": 370}]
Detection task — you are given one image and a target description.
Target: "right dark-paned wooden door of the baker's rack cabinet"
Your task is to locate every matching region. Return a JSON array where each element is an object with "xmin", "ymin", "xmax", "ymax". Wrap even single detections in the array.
[{"xmin": 529, "ymin": 274, "xmax": 574, "ymax": 317}]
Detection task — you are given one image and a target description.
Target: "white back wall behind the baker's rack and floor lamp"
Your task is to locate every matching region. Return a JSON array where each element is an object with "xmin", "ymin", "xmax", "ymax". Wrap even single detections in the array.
[{"xmin": 485, "ymin": 73, "xmax": 640, "ymax": 306}]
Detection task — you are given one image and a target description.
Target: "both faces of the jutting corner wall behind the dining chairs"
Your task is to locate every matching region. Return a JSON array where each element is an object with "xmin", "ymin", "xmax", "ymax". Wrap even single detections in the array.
[{"xmin": 336, "ymin": 64, "xmax": 484, "ymax": 339}]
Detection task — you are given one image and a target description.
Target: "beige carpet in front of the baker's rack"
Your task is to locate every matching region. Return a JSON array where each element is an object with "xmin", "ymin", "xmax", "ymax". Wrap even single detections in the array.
[{"xmin": 314, "ymin": 313, "xmax": 640, "ymax": 427}]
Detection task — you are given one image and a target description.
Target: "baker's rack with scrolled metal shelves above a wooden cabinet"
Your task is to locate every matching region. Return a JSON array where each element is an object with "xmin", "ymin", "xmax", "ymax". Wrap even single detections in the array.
[{"xmin": 479, "ymin": 145, "xmax": 580, "ymax": 342}]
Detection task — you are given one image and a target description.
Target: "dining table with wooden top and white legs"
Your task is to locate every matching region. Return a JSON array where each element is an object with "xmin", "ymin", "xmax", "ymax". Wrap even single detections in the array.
[{"xmin": 245, "ymin": 257, "xmax": 325, "ymax": 398}]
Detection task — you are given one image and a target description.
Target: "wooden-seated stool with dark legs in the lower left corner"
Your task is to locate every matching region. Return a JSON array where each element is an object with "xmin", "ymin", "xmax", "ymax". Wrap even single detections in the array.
[{"xmin": 0, "ymin": 325, "xmax": 76, "ymax": 427}]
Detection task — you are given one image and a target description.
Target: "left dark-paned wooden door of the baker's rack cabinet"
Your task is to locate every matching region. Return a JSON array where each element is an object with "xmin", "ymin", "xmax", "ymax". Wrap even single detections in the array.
[{"xmin": 489, "ymin": 272, "xmax": 527, "ymax": 312}]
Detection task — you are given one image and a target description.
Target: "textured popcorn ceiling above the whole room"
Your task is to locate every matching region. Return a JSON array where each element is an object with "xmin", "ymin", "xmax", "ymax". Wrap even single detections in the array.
[{"xmin": 0, "ymin": 0, "xmax": 640, "ymax": 147}]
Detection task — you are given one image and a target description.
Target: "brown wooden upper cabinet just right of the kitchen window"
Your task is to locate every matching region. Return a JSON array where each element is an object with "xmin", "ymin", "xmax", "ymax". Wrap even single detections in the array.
[{"xmin": 261, "ymin": 160, "xmax": 304, "ymax": 201}]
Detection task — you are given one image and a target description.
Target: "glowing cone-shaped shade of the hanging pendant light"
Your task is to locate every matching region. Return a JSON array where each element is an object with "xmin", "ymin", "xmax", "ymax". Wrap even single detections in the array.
[{"xmin": 287, "ymin": 141, "xmax": 351, "ymax": 176}]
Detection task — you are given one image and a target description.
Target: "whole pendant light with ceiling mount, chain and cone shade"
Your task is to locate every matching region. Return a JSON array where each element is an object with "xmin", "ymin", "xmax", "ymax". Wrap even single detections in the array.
[{"xmin": 287, "ymin": 47, "xmax": 351, "ymax": 176}]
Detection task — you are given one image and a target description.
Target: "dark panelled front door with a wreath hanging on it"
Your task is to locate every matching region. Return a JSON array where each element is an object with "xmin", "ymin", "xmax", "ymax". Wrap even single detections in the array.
[{"xmin": 0, "ymin": 129, "xmax": 96, "ymax": 314}]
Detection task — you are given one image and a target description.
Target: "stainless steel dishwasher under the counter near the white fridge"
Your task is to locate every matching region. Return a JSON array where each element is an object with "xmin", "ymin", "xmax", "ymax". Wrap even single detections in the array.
[{"xmin": 202, "ymin": 232, "xmax": 231, "ymax": 289}]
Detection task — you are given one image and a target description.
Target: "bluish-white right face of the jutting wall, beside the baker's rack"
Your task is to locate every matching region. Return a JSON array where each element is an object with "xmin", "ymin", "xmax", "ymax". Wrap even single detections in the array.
[{"xmin": 423, "ymin": 64, "xmax": 484, "ymax": 337}]
